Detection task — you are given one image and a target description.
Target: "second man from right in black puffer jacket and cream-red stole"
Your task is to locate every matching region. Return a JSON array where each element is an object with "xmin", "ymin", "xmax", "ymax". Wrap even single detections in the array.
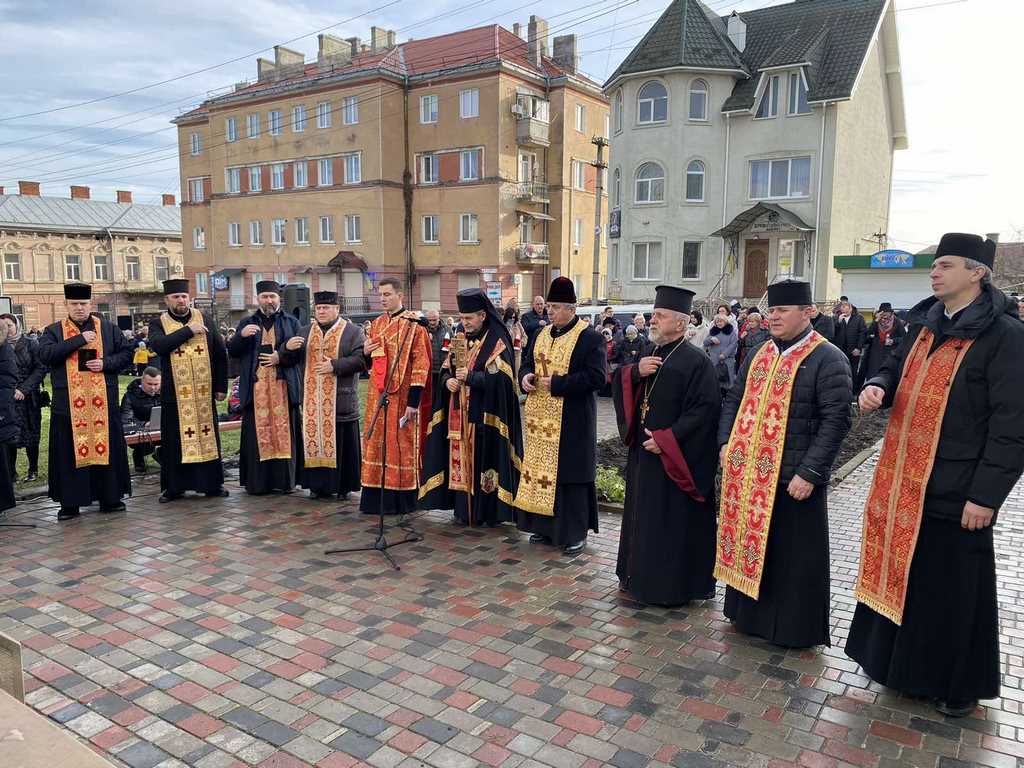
[{"xmin": 715, "ymin": 281, "xmax": 852, "ymax": 648}]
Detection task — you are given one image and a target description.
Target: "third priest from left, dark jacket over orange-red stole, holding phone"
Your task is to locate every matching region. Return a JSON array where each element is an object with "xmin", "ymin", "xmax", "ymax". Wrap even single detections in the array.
[{"xmin": 227, "ymin": 280, "xmax": 303, "ymax": 495}]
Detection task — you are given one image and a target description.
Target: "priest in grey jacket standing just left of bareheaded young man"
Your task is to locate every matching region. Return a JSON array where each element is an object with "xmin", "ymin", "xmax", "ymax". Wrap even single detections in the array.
[{"xmin": 285, "ymin": 291, "xmax": 366, "ymax": 499}]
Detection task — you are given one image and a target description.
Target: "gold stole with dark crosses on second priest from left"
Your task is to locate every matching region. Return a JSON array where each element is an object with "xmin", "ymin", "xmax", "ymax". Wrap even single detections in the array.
[{"xmin": 160, "ymin": 309, "xmax": 220, "ymax": 464}]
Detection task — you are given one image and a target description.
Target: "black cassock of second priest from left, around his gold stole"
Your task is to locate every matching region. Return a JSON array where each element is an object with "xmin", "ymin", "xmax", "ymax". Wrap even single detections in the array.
[{"xmin": 150, "ymin": 311, "xmax": 227, "ymax": 495}]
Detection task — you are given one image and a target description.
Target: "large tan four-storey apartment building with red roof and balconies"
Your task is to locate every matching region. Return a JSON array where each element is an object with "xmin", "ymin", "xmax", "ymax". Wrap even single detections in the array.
[{"xmin": 174, "ymin": 16, "xmax": 608, "ymax": 317}]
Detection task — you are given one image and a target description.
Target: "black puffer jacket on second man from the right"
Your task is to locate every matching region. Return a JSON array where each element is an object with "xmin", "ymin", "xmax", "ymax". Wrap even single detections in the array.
[{"xmin": 718, "ymin": 328, "xmax": 853, "ymax": 485}]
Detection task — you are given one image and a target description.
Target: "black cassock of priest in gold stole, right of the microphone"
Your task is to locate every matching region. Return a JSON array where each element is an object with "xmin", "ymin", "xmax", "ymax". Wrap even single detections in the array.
[{"xmin": 516, "ymin": 317, "xmax": 608, "ymax": 547}]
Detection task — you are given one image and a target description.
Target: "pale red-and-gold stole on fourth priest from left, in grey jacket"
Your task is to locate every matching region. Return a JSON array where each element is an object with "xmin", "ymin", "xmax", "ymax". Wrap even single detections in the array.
[{"xmin": 302, "ymin": 317, "xmax": 347, "ymax": 469}]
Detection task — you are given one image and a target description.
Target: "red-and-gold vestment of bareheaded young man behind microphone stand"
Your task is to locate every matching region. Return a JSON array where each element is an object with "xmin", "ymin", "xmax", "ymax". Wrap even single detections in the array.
[{"xmin": 361, "ymin": 311, "xmax": 432, "ymax": 490}]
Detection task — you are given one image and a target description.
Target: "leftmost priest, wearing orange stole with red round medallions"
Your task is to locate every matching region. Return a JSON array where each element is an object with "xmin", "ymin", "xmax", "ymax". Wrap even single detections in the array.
[{"xmin": 39, "ymin": 283, "xmax": 132, "ymax": 520}]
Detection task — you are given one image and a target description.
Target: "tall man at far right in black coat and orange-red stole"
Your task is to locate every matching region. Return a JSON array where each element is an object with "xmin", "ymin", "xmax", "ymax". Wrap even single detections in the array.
[{"xmin": 846, "ymin": 232, "xmax": 1024, "ymax": 717}]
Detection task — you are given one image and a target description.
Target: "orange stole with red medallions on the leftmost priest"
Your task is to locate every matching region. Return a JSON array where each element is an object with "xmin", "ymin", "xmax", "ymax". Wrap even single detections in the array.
[{"xmin": 60, "ymin": 317, "xmax": 111, "ymax": 469}]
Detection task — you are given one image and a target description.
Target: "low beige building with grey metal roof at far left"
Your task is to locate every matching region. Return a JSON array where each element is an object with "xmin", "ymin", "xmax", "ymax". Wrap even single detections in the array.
[{"xmin": 0, "ymin": 181, "xmax": 184, "ymax": 329}]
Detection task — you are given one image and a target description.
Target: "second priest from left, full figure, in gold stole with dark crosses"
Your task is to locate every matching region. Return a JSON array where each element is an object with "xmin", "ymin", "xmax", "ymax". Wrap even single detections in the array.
[{"xmin": 148, "ymin": 279, "xmax": 227, "ymax": 504}]
